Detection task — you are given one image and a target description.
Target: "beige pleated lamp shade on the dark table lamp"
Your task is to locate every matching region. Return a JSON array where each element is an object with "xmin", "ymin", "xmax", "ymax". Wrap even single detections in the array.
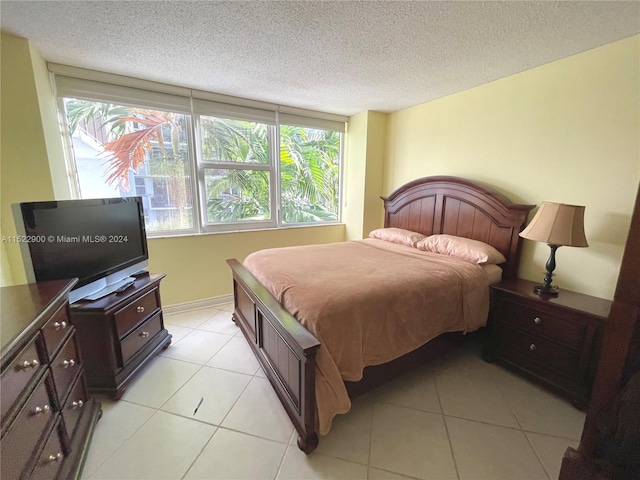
[{"xmin": 520, "ymin": 202, "xmax": 589, "ymax": 247}]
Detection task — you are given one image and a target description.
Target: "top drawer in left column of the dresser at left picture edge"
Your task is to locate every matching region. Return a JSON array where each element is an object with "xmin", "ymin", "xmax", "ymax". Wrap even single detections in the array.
[{"xmin": 0, "ymin": 335, "xmax": 44, "ymax": 423}]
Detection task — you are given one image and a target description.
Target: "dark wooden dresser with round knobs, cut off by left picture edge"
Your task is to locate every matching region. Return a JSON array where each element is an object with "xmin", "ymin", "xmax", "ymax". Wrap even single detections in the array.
[{"xmin": 0, "ymin": 279, "xmax": 102, "ymax": 480}]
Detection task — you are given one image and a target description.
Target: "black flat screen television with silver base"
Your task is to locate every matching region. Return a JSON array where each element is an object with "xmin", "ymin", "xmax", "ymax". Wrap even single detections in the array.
[{"xmin": 12, "ymin": 197, "xmax": 149, "ymax": 303}]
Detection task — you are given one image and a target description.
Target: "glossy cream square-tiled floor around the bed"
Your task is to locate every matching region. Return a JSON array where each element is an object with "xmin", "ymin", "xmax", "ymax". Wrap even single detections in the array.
[{"xmin": 83, "ymin": 305, "xmax": 584, "ymax": 480}]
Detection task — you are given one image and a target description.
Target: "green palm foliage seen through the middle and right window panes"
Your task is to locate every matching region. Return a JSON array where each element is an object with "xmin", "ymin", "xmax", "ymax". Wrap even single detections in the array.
[{"xmin": 206, "ymin": 119, "xmax": 340, "ymax": 223}]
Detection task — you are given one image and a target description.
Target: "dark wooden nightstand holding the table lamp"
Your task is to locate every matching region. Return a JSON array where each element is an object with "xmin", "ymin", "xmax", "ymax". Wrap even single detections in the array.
[{"xmin": 483, "ymin": 279, "xmax": 611, "ymax": 408}]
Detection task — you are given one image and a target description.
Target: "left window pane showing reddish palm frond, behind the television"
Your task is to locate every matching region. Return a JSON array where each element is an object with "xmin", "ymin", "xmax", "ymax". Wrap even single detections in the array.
[{"xmin": 64, "ymin": 98, "xmax": 194, "ymax": 233}]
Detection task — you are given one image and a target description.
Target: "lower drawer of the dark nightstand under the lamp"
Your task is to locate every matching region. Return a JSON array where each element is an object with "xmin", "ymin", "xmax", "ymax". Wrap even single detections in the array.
[{"xmin": 495, "ymin": 327, "xmax": 580, "ymax": 378}]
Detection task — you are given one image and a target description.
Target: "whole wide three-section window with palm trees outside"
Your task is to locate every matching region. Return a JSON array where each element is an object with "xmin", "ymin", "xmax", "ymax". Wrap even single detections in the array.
[{"xmin": 50, "ymin": 65, "xmax": 346, "ymax": 236}]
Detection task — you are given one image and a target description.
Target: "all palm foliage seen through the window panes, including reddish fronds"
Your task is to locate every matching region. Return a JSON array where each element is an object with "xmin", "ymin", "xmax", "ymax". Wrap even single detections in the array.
[{"xmin": 66, "ymin": 99, "xmax": 340, "ymax": 227}]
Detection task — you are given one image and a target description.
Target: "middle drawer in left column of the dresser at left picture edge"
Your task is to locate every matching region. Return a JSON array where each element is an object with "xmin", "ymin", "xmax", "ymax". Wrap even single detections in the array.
[{"xmin": 0, "ymin": 373, "xmax": 54, "ymax": 479}]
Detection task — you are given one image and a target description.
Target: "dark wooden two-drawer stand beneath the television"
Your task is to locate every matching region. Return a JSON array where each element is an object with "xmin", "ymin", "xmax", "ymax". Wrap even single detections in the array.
[{"xmin": 71, "ymin": 273, "xmax": 171, "ymax": 399}]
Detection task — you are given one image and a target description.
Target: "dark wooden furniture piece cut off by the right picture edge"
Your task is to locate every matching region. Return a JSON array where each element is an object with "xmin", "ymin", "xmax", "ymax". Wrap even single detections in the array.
[{"xmin": 559, "ymin": 185, "xmax": 640, "ymax": 480}]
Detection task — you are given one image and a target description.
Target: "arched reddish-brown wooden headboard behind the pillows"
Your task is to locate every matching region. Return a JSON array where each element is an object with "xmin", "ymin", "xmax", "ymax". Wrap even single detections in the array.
[{"xmin": 382, "ymin": 176, "xmax": 535, "ymax": 279}]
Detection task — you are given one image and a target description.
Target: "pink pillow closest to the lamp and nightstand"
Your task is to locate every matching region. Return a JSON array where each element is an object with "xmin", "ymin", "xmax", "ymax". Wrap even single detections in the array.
[{"xmin": 416, "ymin": 235, "xmax": 507, "ymax": 265}]
